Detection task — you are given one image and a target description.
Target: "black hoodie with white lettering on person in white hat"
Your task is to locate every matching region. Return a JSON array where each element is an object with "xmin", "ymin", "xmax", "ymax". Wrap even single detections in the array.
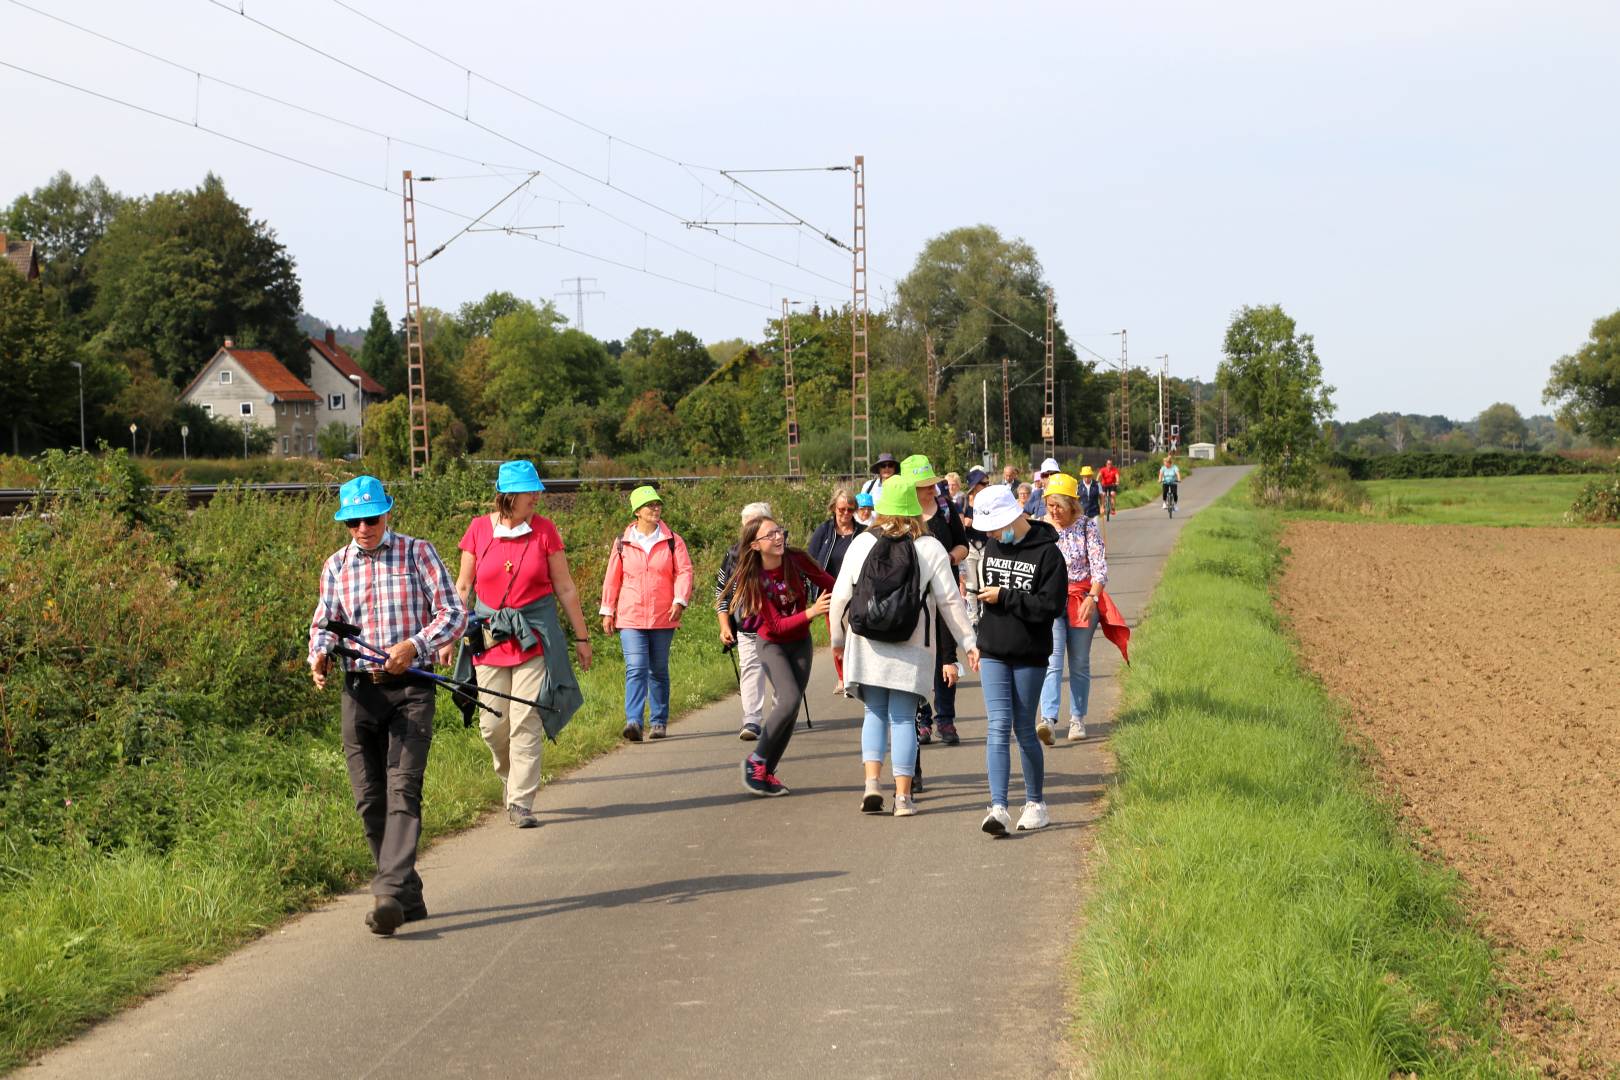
[{"xmin": 978, "ymin": 521, "xmax": 1069, "ymax": 667}]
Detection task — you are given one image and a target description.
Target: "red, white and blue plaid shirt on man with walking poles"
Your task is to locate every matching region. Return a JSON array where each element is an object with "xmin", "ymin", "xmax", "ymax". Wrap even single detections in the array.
[{"xmin": 309, "ymin": 529, "xmax": 467, "ymax": 670}]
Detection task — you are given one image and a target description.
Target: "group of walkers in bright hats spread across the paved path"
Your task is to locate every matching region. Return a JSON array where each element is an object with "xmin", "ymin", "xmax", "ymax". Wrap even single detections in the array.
[{"xmin": 309, "ymin": 453, "xmax": 1128, "ymax": 936}]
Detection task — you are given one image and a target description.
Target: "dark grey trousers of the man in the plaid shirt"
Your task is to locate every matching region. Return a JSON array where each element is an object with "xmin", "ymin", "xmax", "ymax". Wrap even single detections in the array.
[{"xmin": 343, "ymin": 674, "xmax": 434, "ymax": 912}]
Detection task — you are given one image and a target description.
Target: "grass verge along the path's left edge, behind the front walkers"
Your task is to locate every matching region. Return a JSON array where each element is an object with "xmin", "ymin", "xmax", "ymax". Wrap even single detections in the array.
[{"xmin": 0, "ymin": 637, "xmax": 735, "ymax": 1072}]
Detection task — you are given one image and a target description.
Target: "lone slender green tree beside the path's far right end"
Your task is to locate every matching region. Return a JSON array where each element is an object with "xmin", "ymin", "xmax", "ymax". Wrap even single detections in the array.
[{"xmin": 1217, "ymin": 304, "xmax": 1333, "ymax": 502}]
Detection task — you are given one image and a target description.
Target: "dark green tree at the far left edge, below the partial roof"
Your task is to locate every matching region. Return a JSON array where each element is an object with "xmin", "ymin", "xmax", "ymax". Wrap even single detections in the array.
[{"xmin": 0, "ymin": 264, "xmax": 78, "ymax": 453}]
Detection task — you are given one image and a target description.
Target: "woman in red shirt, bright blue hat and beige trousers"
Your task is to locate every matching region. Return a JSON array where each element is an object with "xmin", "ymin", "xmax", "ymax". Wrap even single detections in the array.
[{"xmin": 455, "ymin": 461, "xmax": 591, "ymax": 829}]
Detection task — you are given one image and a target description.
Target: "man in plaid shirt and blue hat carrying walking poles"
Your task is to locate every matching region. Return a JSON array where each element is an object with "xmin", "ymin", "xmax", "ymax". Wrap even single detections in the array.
[{"xmin": 309, "ymin": 476, "xmax": 467, "ymax": 936}]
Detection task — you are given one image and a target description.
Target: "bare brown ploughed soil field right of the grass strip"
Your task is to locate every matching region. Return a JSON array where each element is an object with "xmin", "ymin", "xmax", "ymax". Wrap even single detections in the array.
[{"xmin": 1278, "ymin": 521, "xmax": 1620, "ymax": 1077}]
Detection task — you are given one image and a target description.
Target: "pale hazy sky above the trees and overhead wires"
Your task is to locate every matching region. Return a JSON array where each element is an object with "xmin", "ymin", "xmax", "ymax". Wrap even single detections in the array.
[{"xmin": 0, "ymin": 0, "xmax": 1620, "ymax": 419}]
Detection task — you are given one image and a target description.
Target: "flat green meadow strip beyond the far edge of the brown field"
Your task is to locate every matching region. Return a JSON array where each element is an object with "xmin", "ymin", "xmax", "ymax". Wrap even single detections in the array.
[{"xmin": 1302, "ymin": 476, "xmax": 1592, "ymax": 526}]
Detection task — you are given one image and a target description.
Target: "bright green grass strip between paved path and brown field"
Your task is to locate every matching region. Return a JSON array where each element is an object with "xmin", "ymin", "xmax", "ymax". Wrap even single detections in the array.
[{"xmin": 1074, "ymin": 492, "xmax": 1528, "ymax": 1078}]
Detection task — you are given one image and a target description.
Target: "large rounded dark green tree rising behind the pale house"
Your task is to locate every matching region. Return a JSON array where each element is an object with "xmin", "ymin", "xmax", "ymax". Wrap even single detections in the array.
[{"xmin": 89, "ymin": 173, "xmax": 309, "ymax": 385}]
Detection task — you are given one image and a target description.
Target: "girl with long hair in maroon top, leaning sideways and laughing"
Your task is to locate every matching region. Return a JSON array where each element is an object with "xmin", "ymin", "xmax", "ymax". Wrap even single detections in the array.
[{"xmin": 726, "ymin": 518, "xmax": 833, "ymax": 795}]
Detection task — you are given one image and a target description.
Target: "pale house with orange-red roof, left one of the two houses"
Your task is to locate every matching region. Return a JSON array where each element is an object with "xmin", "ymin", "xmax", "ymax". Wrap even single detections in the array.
[{"xmin": 180, "ymin": 338, "xmax": 321, "ymax": 457}]
